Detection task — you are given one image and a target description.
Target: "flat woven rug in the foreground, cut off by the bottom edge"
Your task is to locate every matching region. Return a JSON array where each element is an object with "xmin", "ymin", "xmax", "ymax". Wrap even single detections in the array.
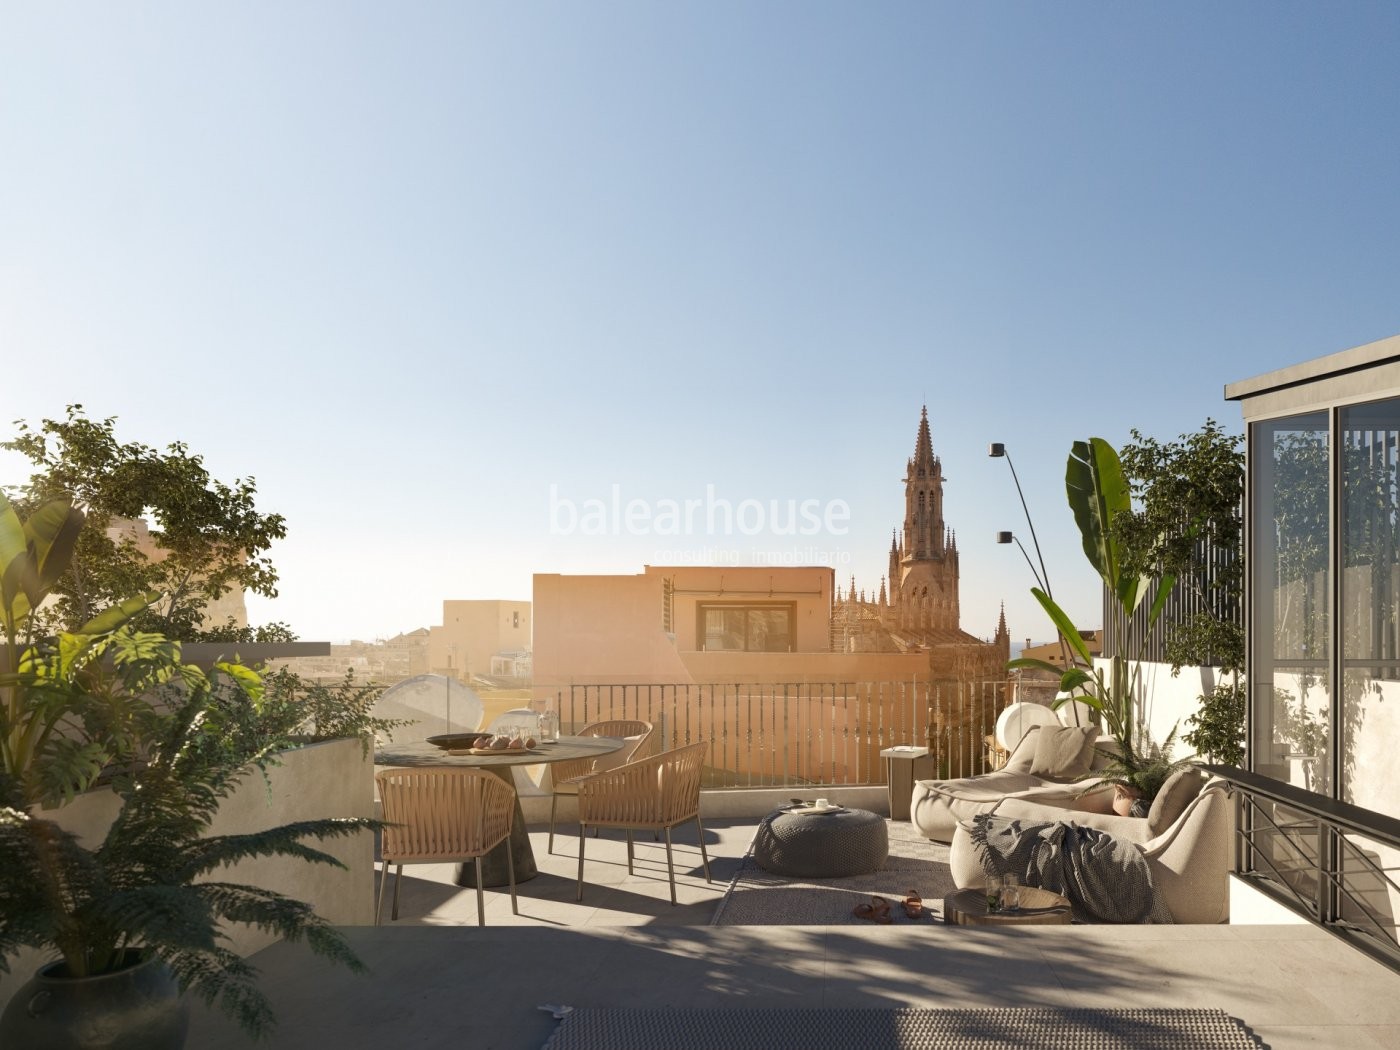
[{"xmin": 545, "ymin": 1007, "xmax": 1263, "ymax": 1050}]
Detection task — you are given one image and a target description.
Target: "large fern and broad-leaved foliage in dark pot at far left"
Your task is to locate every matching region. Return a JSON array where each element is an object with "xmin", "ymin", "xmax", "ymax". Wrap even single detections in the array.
[{"xmin": 0, "ymin": 496, "xmax": 374, "ymax": 1050}]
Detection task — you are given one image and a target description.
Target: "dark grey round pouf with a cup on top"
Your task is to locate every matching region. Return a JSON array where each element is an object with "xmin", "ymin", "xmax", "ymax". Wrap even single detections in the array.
[{"xmin": 753, "ymin": 809, "xmax": 889, "ymax": 879}]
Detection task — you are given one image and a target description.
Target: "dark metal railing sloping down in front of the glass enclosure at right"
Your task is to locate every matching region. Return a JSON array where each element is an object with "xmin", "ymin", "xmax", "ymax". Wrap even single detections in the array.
[{"xmin": 1205, "ymin": 766, "xmax": 1400, "ymax": 969}]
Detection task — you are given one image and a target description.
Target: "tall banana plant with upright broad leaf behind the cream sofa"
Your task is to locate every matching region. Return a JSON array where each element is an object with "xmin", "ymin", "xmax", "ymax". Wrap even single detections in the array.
[{"xmin": 1007, "ymin": 438, "xmax": 1176, "ymax": 764}]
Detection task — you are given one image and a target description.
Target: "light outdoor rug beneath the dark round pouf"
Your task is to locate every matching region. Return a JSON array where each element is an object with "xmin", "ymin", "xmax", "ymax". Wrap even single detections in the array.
[{"xmin": 710, "ymin": 820, "xmax": 958, "ymax": 925}]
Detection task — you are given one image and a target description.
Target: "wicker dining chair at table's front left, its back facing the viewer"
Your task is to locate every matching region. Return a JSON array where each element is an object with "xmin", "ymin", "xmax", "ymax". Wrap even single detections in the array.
[{"xmin": 374, "ymin": 766, "xmax": 519, "ymax": 925}]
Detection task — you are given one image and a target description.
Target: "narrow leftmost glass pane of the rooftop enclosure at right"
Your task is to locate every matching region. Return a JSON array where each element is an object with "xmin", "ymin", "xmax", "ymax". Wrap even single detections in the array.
[{"xmin": 1249, "ymin": 412, "xmax": 1334, "ymax": 795}]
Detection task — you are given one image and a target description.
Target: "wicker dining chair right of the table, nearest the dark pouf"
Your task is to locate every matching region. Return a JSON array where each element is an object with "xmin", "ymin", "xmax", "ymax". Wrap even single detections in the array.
[{"xmin": 578, "ymin": 741, "xmax": 710, "ymax": 904}]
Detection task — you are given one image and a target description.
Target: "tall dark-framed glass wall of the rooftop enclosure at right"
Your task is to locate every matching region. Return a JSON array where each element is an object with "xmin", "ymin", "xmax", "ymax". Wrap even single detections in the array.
[{"xmin": 1250, "ymin": 399, "xmax": 1400, "ymax": 816}]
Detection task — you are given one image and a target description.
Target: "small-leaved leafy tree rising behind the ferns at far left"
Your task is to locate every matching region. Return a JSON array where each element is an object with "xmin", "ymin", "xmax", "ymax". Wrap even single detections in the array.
[{"xmin": 0, "ymin": 405, "xmax": 287, "ymax": 641}]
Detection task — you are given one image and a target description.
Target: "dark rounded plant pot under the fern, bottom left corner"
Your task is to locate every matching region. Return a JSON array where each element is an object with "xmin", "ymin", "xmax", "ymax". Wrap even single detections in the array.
[{"xmin": 0, "ymin": 949, "xmax": 189, "ymax": 1050}]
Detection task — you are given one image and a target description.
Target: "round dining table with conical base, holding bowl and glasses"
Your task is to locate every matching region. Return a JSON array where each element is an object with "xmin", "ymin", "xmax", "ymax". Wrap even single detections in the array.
[{"xmin": 374, "ymin": 736, "xmax": 624, "ymax": 888}]
